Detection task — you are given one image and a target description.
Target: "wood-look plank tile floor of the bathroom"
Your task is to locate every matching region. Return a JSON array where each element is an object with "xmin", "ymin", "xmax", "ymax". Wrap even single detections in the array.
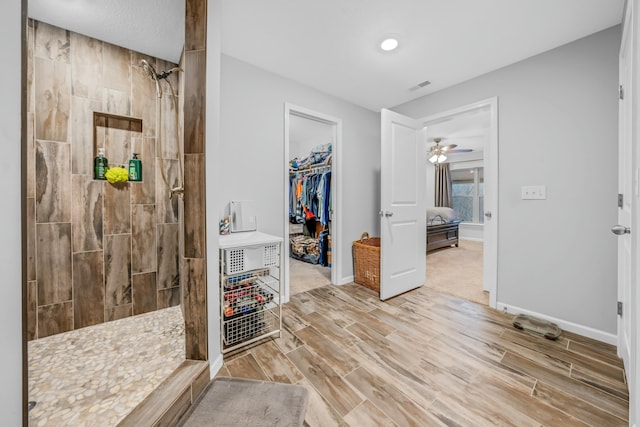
[{"xmin": 218, "ymin": 284, "xmax": 628, "ymax": 427}]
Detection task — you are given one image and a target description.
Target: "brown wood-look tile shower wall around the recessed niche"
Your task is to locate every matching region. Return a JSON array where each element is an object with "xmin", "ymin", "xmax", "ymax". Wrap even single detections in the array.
[{"xmin": 26, "ymin": 21, "xmax": 180, "ymax": 340}]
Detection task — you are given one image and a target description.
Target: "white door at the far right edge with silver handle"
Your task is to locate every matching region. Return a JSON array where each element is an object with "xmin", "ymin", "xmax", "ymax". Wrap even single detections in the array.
[{"xmin": 612, "ymin": 2, "xmax": 636, "ymax": 396}]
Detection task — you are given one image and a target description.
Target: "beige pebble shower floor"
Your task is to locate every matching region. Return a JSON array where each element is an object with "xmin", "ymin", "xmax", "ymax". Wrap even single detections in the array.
[{"xmin": 28, "ymin": 306, "xmax": 185, "ymax": 427}]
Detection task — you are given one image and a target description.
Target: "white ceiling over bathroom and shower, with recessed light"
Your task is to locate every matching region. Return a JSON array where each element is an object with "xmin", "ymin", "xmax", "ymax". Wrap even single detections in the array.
[{"xmin": 28, "ymin": 0, "xmax": 624, "ymax": 111}]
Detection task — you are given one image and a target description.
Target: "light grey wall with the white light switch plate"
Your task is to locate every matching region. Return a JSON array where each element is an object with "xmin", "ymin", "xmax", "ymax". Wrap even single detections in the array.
[{"xmin": 394, "ymin": 27, "xmax": 620, "ymax": 341}]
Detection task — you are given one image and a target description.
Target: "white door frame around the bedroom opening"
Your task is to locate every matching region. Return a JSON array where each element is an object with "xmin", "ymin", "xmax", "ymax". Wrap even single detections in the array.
[{"xmin": 422, "ymin": 96, "xmax": 499, "ymax": 308}]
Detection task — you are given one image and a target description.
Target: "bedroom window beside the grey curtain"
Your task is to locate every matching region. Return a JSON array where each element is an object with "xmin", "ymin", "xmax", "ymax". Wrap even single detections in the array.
[{"xmin": 451, "ymin": 167, "xmax": 484, "ymax": 224}]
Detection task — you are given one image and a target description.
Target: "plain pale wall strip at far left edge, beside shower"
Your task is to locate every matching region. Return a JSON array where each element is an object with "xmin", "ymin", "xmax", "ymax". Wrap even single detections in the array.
[{"xmin": 0, "ymin": 1, "xmax": 26, "ymax": 426}]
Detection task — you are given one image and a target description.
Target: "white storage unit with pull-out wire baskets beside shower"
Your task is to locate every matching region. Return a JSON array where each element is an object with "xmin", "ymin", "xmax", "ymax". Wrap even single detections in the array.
[{"xmin": 220, "ymin": 232, "xmax": 282, "ymax": 353}]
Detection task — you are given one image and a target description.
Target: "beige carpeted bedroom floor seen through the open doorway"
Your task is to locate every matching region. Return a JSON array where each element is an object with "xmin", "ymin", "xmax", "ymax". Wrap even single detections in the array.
[{"xmin": 426, "ymin": 240, "xmax": 489, "ymax": 305}]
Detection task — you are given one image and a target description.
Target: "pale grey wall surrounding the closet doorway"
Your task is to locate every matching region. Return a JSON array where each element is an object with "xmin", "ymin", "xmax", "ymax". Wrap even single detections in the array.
[{"xmin": 220, "ymin": 55, "xmax": 380, "ymax": 280}]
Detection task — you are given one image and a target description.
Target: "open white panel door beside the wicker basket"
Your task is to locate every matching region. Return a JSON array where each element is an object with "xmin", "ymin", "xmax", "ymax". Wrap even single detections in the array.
[{"xmin": 380, "ymin": 109, "xmax": 427, "ymax": 300}]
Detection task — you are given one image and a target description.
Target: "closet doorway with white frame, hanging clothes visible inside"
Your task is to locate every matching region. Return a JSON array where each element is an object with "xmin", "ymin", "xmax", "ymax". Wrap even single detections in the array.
[{"xmin": 282, "ymin": 103, "xmax": 342, "ymax": 301}]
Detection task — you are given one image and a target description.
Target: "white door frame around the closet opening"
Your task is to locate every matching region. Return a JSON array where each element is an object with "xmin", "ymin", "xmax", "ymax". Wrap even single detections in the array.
[{"xmin": 280, "ymin": 102, "xmax": 343, "ymax": 302}]
